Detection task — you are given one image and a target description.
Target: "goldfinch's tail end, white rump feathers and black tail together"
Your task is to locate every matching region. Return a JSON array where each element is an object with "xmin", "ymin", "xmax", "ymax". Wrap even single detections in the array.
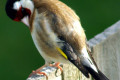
[{"xmin": 79, "ymin": 48, "xmax": 109, "ymax": 80}]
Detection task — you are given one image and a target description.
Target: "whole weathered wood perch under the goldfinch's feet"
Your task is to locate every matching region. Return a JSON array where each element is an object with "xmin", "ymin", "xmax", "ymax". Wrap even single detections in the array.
[{"xmin": 27, "ymin": 64, "xmax": 91, "ymax": 80}]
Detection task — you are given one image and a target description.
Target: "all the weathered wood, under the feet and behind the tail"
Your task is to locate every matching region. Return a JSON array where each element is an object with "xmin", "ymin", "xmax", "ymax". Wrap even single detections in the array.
[{"xmin": 27, "ymin": 21, "xmax": 120, "ymax": 80}]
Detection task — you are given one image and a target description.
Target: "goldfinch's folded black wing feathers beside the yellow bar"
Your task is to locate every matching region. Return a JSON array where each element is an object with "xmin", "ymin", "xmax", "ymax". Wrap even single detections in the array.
[{"xmin": 60, "ymin": 37, "xmax": 89, "ymax": 78}]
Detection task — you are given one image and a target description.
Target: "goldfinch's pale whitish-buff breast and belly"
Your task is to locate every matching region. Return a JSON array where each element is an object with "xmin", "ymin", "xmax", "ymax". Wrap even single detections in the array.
[{"xmin": 31, "ymin": 11, "xmax": 64, "ymax": 62}]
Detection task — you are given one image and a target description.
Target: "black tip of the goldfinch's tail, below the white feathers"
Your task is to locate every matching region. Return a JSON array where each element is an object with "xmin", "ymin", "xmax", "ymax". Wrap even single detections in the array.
[{"xmin": 86, "ymin": 67, "xmax": 109, "ymax": 80}]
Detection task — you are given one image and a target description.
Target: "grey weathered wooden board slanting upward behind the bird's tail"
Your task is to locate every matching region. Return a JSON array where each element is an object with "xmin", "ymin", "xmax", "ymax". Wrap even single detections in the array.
[{"xmin": 89, "ymin": 21, "xmax": 120, "ymax": 80}]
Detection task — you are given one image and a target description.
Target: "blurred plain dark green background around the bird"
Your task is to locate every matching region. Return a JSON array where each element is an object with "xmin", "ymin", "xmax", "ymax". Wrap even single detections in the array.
[{"xmin": 0, "ymin": 0, "xmax": 120, "ymax": 80}]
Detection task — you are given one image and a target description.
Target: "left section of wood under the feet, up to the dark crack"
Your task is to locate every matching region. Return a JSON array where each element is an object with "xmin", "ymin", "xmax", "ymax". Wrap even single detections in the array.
[{"xmin": 27, "ymin": 66, "xmax": 62, "ymax": 80}]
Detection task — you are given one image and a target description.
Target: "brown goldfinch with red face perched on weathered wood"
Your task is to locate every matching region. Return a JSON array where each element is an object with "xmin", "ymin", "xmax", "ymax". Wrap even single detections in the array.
[{"xmin": 5, "ymin": 0, "xmax": 109, "ymax": 80}]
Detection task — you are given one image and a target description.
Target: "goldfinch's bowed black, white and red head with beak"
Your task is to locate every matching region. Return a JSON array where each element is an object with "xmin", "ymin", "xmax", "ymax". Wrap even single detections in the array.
[{"xmin": 5, "ymin": 0, "xmax": 34, "ymax": 26}]
